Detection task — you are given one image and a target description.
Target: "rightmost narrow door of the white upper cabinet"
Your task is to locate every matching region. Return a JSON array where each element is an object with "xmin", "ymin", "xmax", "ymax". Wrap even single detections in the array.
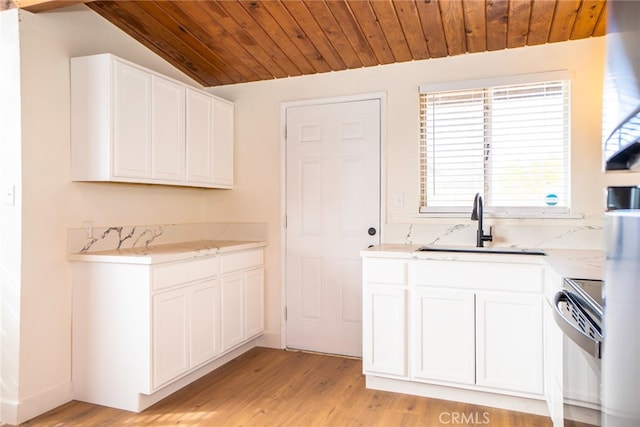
[{"xmin": 213, "ymin": 99, "xmax": 234, "ymax": 187}]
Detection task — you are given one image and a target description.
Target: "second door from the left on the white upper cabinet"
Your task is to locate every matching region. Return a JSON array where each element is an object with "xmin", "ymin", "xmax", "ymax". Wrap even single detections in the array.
[{"xmin": 151, "ymin": 76, "xmax": 185, "ymax": 182}]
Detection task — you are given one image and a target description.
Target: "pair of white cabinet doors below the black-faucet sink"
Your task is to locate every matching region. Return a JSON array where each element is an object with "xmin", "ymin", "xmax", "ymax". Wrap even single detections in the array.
[{"xmin": 412, "ymin": 289, "xmax": 543, "ymax": 393}]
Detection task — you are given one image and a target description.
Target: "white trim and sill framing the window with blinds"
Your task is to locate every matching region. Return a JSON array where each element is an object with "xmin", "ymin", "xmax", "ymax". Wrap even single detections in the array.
[{"xmin": 418, "ymin": 70, "xmax": 575, "ymax": 218}]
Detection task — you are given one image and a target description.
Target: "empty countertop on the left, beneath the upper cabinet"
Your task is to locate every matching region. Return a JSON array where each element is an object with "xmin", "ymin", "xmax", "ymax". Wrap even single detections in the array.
[{"xmin": 68, "ymin": 240, "xmax": 267, "ymax": 264}]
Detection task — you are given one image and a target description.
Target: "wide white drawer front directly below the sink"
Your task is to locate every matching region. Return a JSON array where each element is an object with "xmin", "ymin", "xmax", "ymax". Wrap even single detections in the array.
[{"xmin": 409, "ymin": 261, "xmax": 544, "ymax": 292}]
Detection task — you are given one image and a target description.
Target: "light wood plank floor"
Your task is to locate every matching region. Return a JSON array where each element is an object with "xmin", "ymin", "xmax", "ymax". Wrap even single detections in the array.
[{"xmin": 21, "ymin": 348, "xmax": 551, "ymax": 427}]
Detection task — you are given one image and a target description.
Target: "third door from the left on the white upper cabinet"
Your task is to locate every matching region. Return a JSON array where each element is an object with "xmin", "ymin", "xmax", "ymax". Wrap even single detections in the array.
[{"xmin": 186, "ymin": 88, "xmax": 214, "ymax": 184}]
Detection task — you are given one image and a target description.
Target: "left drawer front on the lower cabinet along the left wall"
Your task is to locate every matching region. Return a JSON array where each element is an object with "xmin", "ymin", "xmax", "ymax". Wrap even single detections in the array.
[{"xmin": 152, "ymin": 256, "xmax": 218, "ymax": 291}]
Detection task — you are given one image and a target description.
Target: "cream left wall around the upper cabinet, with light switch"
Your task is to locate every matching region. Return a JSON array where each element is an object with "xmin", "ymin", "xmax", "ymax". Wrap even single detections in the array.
[{"xmin": 0, "ymin": 6, "xmax": 215, "ymax": 423}]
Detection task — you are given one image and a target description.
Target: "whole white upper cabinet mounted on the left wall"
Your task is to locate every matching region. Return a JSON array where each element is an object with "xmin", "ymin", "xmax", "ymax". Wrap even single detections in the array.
[{"xmin": 71, "ymin": 54, "xmax": 234, "ymax": 188}]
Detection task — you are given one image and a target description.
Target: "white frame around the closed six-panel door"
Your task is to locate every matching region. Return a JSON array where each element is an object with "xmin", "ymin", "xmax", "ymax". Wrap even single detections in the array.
[{"xmin": 280, "ymin": 92, "xmax": 387, "ymax": 348}]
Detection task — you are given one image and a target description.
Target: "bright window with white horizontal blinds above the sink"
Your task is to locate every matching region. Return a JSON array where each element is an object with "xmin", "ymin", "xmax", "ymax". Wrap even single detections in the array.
[{"xmin": 420, "ymin": 72, "xmax": 571, "ymax": 216}]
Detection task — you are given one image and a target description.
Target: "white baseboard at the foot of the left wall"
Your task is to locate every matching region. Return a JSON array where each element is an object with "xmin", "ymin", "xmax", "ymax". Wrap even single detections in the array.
[{"xmin": 0, "ymin": 381, "xmax": 73, "ymax": 425}]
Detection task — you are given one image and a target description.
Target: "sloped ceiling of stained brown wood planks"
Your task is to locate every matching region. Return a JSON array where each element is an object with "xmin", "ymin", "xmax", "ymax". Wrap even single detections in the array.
[{"xmin": 7, "ymin": 0, "xmax": 606, "ymax": 86}]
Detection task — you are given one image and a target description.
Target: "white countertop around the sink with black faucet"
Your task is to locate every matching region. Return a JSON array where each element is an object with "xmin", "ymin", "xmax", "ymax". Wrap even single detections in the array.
[{"xmin": 361, "ymin": 244, "xmax": 604, "ymax": 280}]
